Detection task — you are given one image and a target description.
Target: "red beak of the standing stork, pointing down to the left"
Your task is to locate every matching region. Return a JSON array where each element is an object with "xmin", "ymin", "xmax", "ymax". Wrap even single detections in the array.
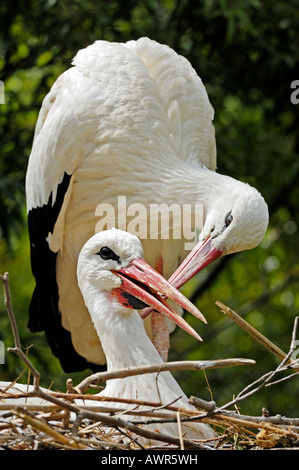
[{"xmin": 169, "ymin": 237, "xmax": 223, "ymax": 289}]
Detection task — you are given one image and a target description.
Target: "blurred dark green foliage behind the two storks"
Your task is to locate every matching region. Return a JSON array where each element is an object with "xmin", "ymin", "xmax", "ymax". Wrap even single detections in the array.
[{"xmin": 0, "ymin": 0, "xmax": 299, "ymax": 416}]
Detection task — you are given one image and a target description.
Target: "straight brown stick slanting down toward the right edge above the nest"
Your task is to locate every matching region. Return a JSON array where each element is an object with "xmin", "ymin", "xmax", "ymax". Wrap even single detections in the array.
[{"xmin": 216, "ymin": 300, "xmax": 298, "ymax": 369}]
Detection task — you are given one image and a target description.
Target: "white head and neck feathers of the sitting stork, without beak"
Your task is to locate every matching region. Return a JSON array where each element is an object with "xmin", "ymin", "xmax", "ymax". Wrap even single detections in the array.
[{"xmin": 77, "ymin": 230, "xmax": 215, "ymax": 439}]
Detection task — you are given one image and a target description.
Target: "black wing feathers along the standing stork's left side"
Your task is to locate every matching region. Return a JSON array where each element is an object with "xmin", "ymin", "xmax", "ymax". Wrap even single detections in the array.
[{"xmin": 28, "ymin": 173, "xmax": 105, "ymax": 372}]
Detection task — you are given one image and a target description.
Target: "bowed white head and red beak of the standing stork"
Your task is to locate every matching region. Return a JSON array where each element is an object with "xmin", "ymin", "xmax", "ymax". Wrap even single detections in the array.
[{"xmin": 169, "ymin": 177, "xmax": 269, "ymax": 289}]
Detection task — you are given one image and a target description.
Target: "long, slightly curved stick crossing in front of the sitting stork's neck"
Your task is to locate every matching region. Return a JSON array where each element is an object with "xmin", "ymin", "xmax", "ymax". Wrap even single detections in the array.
[{"xmin": 74, "ymin": 358, "xmax": 255, "ymax": 393}]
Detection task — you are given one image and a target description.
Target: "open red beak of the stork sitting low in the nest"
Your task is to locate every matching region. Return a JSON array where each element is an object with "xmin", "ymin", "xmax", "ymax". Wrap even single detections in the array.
[{"xmin": 113, "ymin": 259, "xmax": 206, "ymax": 340}]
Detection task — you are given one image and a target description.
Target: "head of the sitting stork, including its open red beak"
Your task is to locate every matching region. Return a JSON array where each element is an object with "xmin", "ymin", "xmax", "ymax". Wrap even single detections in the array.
[{"xmin": 77, "ymin": 229, "xmax": 205, "ymax": 339}]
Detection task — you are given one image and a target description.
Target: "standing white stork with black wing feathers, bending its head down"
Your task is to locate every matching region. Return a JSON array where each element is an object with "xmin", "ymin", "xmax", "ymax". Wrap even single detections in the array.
[{"xmin": 26, "ymin": 38, "xmax": 268, "ymax": 371}]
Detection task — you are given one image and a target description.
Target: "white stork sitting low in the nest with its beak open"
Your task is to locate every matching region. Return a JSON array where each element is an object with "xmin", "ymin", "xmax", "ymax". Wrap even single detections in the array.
[{"xmin": 0, "ymin": 229, "xmax": 215, "ymax": 443}]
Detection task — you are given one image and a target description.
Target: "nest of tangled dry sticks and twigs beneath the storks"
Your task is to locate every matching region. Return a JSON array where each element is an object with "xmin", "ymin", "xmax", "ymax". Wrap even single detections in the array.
[{"xmin": 0, "ymin": 274, "xmax": 299, "ymax": 451}]
